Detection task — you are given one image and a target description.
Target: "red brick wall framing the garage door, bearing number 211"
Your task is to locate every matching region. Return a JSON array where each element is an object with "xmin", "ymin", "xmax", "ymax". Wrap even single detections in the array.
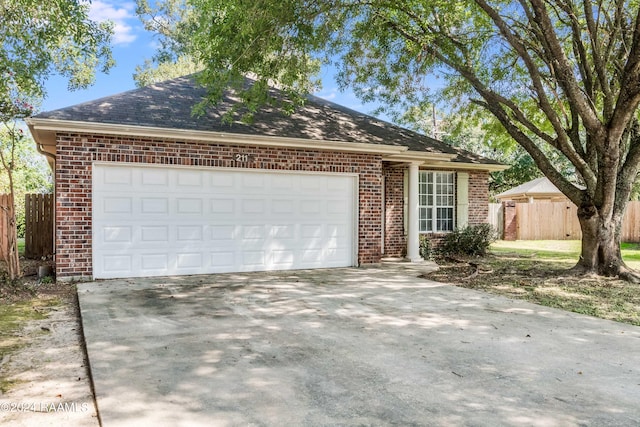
[{"xmin": 55, "ymin": 133, "xmax": 382, "ymax": 279}]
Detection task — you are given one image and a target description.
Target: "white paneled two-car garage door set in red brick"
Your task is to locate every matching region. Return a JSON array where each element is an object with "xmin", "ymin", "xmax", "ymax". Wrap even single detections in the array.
[{"xmin": 93, "ymin": 164, "xmax": 357, "ymax": 278}]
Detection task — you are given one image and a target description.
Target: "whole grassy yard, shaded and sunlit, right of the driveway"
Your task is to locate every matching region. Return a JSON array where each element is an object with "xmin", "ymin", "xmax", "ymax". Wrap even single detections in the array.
[{"xmin": 426, "ymin": 241, "xmax": 640, "ymax": 326}]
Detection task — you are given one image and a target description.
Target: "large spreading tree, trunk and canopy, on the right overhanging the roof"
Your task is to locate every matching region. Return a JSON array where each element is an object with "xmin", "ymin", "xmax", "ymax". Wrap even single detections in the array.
[{"xmin": 141, "ymin": 0, "xmax": 640, "ymax": 275}]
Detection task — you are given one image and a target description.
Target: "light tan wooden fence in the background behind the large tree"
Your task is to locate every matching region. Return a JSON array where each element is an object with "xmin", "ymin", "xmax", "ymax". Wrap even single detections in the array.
[{"xmin": 489, "ymin": 202, "xmax": 640, "ymax": 242}]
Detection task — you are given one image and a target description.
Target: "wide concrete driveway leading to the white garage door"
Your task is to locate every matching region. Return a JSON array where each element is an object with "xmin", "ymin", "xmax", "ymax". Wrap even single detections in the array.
[{"xmin": 78, "ymin": 264, "xmax": 640, "ymax": 427}]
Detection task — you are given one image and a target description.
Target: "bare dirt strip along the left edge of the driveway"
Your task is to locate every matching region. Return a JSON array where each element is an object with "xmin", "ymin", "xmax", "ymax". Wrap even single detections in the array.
[{"xmin": 0, "ymin": 260, "xmax": 99, "ymax": 427}]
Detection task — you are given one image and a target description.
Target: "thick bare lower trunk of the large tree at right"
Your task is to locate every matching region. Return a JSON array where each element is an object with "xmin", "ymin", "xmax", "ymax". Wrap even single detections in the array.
[{"xmin": 574, "ymin": 205, "xmax": 640, "ymax": 283}]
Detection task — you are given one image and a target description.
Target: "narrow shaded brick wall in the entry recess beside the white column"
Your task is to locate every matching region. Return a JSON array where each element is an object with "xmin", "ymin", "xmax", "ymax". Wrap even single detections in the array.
[{"xmin": 382, "ymin": 163, "xmax": 407, "ymax": 257}]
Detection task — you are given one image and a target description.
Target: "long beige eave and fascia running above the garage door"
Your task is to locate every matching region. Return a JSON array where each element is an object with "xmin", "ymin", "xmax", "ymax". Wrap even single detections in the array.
[{"xmin": 26, "ymin": 117, "xmax": 408, "ymax": 157}]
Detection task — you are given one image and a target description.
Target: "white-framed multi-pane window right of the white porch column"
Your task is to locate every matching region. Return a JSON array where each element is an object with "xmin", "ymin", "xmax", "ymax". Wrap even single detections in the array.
[{"xmin": 418, "ymin": 171, "xmax": 456, "ymax": 233}]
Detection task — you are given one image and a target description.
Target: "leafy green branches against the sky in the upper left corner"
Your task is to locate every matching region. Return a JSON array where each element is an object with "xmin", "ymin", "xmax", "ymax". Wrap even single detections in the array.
[{"xmin": 0, "ymin": 0, "xmax": 113, "ymax": 117}]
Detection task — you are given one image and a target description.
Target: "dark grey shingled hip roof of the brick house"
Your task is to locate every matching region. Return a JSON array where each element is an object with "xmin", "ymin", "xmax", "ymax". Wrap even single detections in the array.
[{"xmin": 34, "ymin": 76, "xmax": 499, "ymax": 166}]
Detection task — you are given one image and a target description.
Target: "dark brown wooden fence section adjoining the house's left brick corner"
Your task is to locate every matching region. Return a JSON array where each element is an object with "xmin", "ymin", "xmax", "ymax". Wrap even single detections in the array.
[{"xmin": 24, "ymin": 194, "xmax": 53, "ymax": 258}]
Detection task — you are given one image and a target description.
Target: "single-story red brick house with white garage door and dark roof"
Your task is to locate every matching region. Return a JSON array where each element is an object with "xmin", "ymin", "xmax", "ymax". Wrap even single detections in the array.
[{"xmin": 27, "ymin": 76, "xmax": 504, "ymax": 280}]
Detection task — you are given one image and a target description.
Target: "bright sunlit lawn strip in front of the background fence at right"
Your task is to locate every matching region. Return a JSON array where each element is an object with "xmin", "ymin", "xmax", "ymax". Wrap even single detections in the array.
[{"xmin": 490, "ymin": 240, "xmax": 640, "ymax": 270}]
